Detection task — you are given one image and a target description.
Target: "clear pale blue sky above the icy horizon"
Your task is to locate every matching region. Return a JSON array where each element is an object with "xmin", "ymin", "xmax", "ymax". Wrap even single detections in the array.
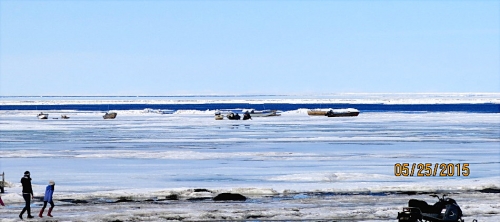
[{"xmin": 0, "ymin": 0, "xmax": 500, "ymax": 96}]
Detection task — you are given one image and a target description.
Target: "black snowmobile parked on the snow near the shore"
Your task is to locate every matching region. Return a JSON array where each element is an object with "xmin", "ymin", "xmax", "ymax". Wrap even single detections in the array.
[{"xmin": 398, "ymin": 194, "xmax": 464, "ymax": 222}]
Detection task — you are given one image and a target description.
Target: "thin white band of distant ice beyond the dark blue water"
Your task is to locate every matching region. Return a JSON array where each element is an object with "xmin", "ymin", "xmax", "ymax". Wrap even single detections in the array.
[{"xmin": 0, "ymin": 93, "xmax": 500, "ymax": 105}]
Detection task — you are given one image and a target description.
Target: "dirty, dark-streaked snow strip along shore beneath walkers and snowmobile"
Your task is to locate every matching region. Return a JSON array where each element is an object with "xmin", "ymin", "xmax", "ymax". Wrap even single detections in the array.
[{"xmin": 0, "ymin": 191, "xmax": 500, "ymax": 222}]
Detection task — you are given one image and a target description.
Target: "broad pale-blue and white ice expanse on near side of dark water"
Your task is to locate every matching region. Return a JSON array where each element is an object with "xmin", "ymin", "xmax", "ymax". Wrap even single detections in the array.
[{"xmin": 0, "ymin": 107, "xmax": 500, "ymax": 221}]
